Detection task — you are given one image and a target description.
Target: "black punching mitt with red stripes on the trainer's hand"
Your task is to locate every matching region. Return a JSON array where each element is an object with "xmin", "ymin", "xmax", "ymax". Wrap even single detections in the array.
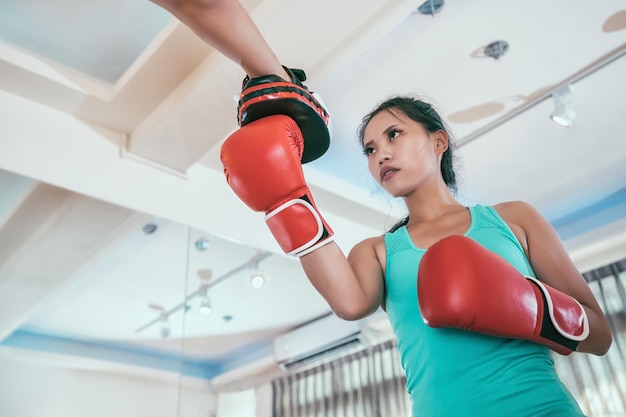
[{"xmin": 237, "ymin": 67, "xmax": 330, "ymax": 164}]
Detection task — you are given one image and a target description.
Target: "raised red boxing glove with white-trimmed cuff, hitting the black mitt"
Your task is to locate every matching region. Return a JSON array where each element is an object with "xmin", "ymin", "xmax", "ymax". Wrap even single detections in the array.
[{"xmin": 220, "ymin": 115, "xmax": 333, "ymax": 256}]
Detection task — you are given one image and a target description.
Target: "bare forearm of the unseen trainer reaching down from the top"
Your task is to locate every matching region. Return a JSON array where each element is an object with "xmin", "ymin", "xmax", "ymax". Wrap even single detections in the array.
[{"xmin": 151, "ymin": 0, "xmax": 289, "ymax": 80}]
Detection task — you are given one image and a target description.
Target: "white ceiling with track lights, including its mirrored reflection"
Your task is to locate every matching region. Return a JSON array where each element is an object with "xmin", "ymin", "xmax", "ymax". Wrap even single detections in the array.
[{"xmin": 0, "ymin": 0, "xmax": 626, "ymax": 390}]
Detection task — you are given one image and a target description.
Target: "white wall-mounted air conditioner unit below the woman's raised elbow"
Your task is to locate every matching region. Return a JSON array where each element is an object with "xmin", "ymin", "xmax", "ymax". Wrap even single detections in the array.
[{"xmin": 274, "ymin": 314, "xmax": 366, "ymax": 370}]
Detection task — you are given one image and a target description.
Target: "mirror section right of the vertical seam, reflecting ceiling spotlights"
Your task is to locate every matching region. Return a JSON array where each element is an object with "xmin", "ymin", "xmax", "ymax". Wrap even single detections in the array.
[{"xmin": 180, "ymin": 229, "xmax": 329, "ymax": 416}]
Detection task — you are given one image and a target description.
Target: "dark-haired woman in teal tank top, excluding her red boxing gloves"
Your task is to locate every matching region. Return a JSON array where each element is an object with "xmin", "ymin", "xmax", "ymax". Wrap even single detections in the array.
[{"xmin": 301, "ymin": 97, "xmax": 612, "ymax": 416}]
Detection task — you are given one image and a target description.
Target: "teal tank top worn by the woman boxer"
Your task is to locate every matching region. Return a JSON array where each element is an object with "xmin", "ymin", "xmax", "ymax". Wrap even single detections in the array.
[{"xmin": 385, "ymin": 205, "xmax": 584, "ymax": 417}]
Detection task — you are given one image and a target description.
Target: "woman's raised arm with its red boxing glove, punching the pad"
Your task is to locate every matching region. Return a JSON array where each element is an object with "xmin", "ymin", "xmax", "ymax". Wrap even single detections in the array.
[{"xmin": 220, "ymin": 115, "xmax": 384, "ymax": 320}]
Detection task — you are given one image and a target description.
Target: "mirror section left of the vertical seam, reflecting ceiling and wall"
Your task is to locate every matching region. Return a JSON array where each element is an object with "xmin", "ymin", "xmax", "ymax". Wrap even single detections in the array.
[{"xmin": 0, "ymin": 171, "xmax": 205, "ymax": 417}]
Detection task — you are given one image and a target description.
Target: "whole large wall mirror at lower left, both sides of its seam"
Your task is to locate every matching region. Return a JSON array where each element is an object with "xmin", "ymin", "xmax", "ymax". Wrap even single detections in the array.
[{"xmin": 0, "ymin": 167, "xmax": 329, "ymax": 417}]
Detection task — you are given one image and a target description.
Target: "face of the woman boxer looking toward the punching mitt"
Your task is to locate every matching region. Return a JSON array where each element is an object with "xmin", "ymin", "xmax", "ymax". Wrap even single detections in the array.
[{"xmin": 363, "ymin": 109, "xmax": 448, "ymax": 197}]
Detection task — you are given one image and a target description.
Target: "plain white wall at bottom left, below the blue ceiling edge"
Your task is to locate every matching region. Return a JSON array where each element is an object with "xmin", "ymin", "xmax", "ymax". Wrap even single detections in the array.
[{"xmin": 0, "ymin": 349, "xmax": 217, "ymax": 417}]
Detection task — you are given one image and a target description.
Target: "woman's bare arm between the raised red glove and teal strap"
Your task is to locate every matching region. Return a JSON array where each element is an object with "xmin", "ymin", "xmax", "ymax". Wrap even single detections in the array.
[{"xmin": 300, "ymin": 237, "xmax": 385, "ymax": 320}]
